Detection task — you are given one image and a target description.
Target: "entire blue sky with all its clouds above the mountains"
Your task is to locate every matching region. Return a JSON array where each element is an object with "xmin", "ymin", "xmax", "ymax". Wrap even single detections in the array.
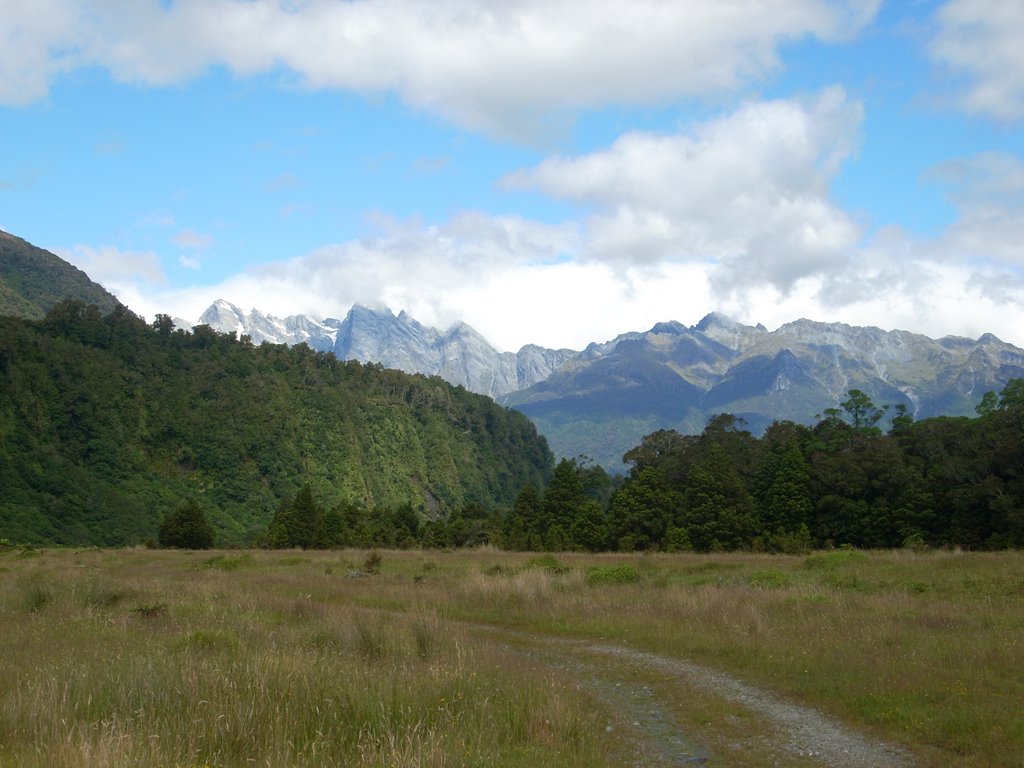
[{"xmin": 0, "ymin": 0, "xmax": 1024, "ymax": 350}]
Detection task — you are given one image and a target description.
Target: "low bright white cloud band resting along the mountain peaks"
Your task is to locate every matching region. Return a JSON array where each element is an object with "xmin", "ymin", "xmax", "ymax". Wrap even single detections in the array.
[{"xmin": 109, "ymin": 217, "xmax": 1024, "ymax": 350}]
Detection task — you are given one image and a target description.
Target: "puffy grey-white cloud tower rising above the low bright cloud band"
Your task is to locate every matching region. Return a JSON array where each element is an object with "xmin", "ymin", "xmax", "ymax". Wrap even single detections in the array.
[{"xmin": 505, "ymin": 88, "xmax": 863, "ymax": 294}]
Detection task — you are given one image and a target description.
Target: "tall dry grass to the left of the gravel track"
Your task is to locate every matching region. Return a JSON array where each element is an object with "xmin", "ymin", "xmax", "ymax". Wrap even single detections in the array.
[{"xmin": 0, "ymin": 551, "xmax": 608, "ymax": 768}]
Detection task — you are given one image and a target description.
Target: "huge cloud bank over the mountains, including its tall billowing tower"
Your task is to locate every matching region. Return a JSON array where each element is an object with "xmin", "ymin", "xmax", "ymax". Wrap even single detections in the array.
[{"xmin": 96, "ymin": 81, "xmax": 1024, "ymax": 349}]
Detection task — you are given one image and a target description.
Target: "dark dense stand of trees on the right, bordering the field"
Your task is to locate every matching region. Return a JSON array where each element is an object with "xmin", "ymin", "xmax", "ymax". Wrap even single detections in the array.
[{"xmin": 493, "ymin": 391, "xmax": 1024, "ymax": 552}]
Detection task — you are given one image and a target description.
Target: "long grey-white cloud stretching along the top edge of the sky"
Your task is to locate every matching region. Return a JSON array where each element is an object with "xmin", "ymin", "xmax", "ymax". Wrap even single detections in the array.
[{"xmin": 0, "ymin": 0, "xmax": 880, "ymax": 136}]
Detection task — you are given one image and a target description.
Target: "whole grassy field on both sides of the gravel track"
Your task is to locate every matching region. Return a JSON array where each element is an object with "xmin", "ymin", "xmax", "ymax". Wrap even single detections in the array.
[{"xmin": 0, "ymin": 549, "xmax": 1024, "ymax": 768}]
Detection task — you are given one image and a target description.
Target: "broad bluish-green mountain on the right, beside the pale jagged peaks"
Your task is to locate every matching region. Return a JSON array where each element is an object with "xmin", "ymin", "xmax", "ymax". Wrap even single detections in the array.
[{"xmin": 502, "ymin": 314, "xmax": 1024, "ymax": 467}]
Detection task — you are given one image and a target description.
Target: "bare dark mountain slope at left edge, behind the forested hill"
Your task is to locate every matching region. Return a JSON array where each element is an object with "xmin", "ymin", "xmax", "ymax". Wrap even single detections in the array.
[{"xmin": 0, "ymin": 230, "xmax": 119, "ymax": 319}]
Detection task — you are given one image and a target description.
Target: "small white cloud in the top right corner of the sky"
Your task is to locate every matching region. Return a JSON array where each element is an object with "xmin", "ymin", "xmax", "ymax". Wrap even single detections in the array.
[{"xmin": 931, "ymin": 0, "xmax": 1024, "ymax": 120}]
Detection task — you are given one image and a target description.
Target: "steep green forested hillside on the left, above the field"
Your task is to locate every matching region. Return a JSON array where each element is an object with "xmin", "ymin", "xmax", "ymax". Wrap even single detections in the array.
[{"xmin": 0, "ymin": 302, "xmax": 552, "ymax": 545}]
